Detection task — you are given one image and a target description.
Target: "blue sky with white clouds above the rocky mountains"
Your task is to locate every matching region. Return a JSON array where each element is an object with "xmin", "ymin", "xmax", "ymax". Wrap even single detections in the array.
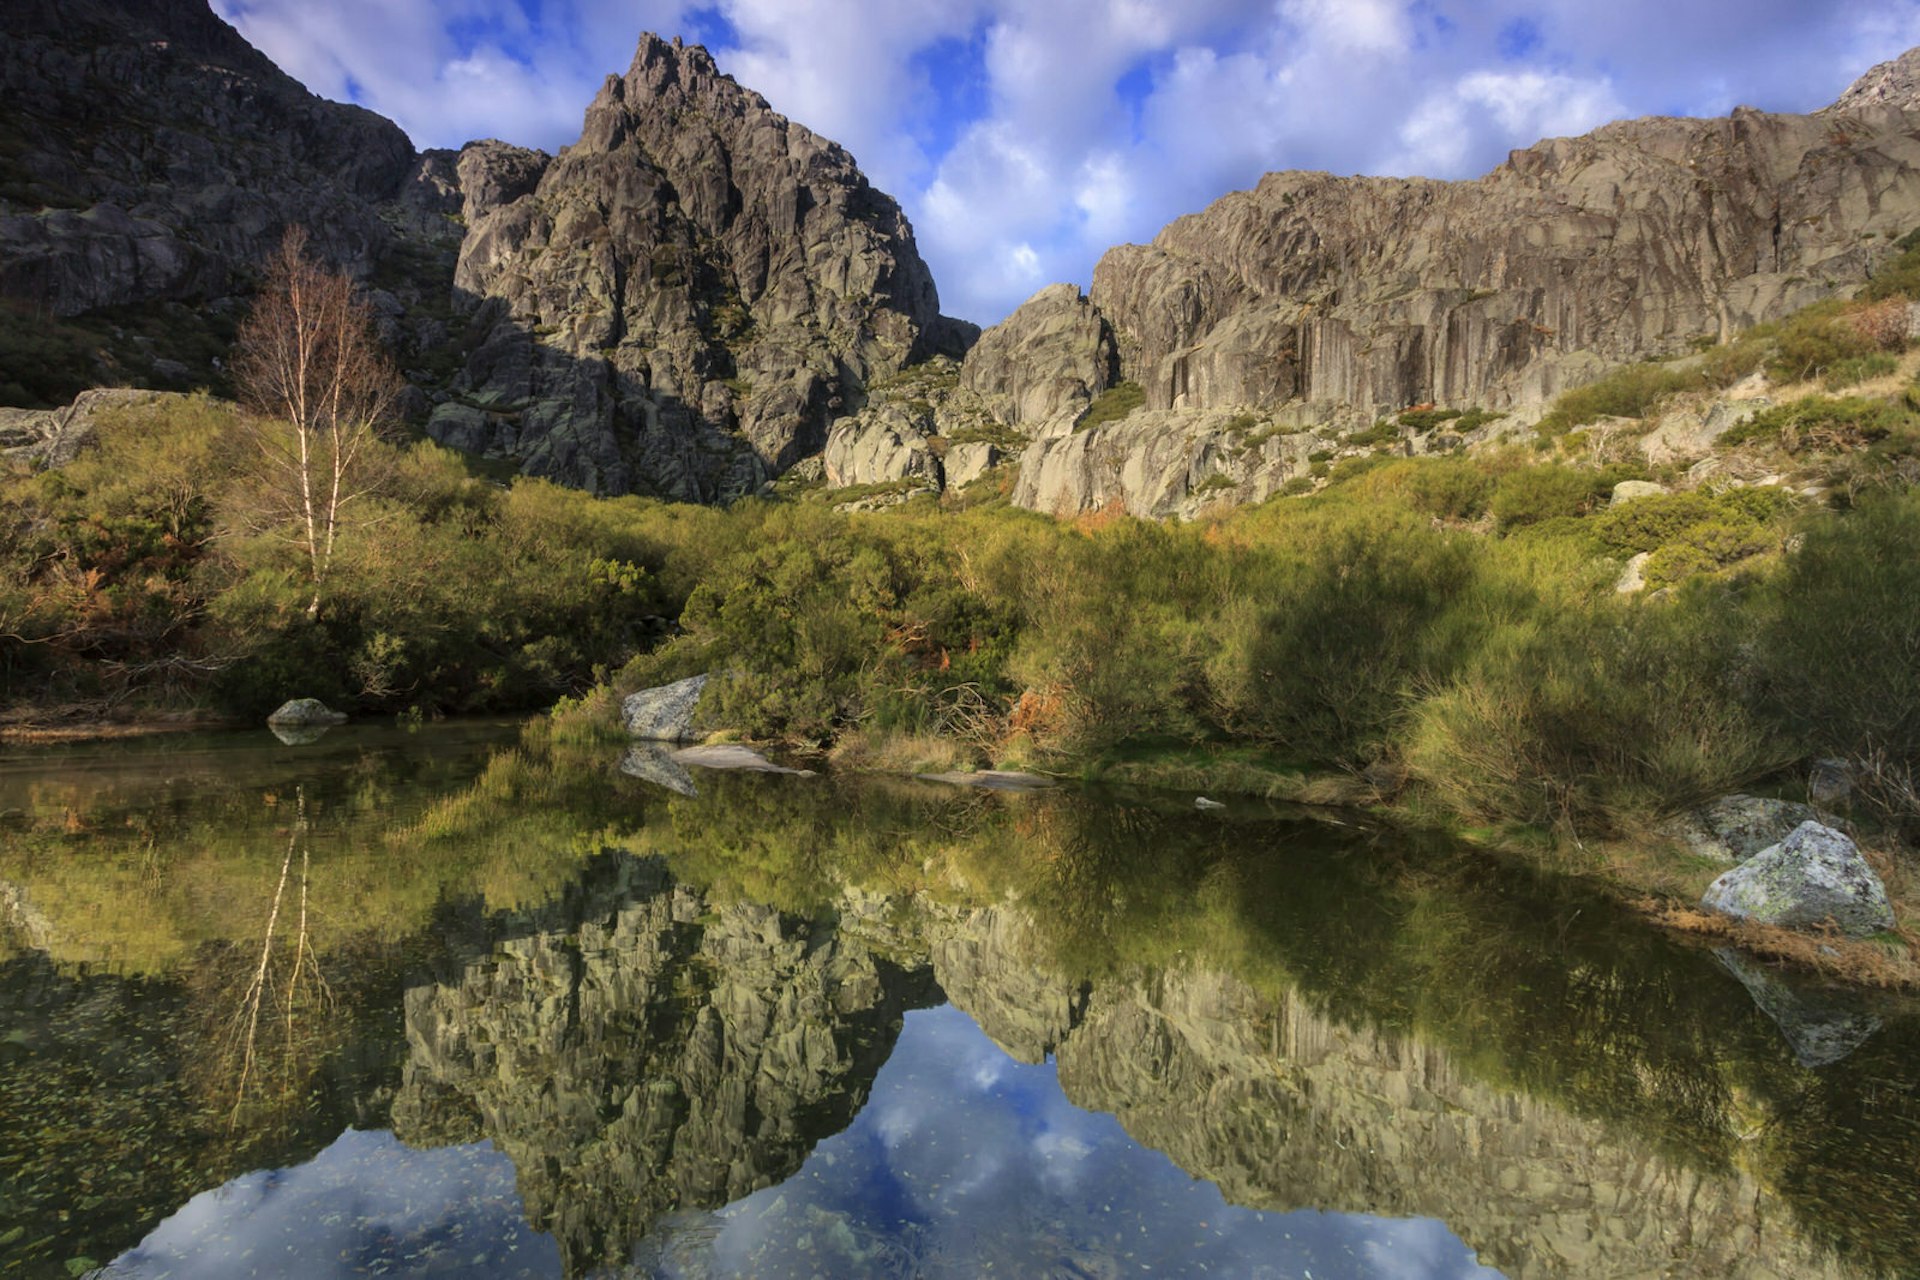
[{"xmin": 213, "ymin": 0, "xmax": 1920, "ymax": 324}]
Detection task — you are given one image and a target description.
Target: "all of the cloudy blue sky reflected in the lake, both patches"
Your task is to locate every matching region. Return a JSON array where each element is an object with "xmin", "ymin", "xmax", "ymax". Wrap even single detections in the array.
[{"xmin": 111, "ymin": 1006, "xmax": 1498, "ymax": 1280}]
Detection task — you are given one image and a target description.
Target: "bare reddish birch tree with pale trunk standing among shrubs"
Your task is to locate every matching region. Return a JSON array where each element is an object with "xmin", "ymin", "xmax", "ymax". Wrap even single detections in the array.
[{"xmin": 232, "ymin": 226, "xmax": 403, "ymax": 616}]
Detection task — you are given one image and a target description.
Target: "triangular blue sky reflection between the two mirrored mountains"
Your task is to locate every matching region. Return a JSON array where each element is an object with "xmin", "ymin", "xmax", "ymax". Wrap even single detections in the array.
[{"xmin": 683, "ymin": 1006, "xmax": 1496, "ymax": 1280}]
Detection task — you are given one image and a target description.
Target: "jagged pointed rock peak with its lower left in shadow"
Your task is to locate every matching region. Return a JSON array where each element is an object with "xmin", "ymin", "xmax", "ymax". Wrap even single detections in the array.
[{"xmin": 430, "ymin": 35, "xmax": 960, "ymax": 501}]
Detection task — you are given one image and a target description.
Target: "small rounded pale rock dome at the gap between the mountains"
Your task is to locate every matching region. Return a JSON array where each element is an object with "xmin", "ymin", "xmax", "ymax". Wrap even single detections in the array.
[{"xmin": 960, "ymin": 284, "xmax": 1117, "ymax": 434}]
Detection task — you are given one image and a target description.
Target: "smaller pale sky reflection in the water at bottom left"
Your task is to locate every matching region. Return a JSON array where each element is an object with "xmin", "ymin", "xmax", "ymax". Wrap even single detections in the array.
[{"xmin": 106, "ymin": 1130, "xmax": 561, "ymax": 1280}]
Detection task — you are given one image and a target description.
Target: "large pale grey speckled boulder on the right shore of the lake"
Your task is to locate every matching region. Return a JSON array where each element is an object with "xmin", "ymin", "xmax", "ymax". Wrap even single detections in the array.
[{"xmin": 1699, "ymin": 821, "xmax": 1893, "ymax": 938}]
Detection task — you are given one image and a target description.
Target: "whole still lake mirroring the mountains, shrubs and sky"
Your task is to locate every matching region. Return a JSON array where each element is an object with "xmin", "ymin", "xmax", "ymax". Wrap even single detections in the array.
[{"xmin": 0, "ymin": 723, "xmax": 1920, "ymax": 1280}]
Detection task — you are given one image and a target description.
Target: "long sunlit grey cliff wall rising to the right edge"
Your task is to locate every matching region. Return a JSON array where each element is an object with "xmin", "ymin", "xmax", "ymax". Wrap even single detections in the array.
[{"xmin": 962, "ymin": 69, "xmax": 1920, "ymax": 514}]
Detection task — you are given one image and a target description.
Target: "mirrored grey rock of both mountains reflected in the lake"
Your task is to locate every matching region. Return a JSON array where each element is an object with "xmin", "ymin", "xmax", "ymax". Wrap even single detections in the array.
[{"xmin": 378, "ymin": 840, "xmax": 1904, "ymax": 1278}]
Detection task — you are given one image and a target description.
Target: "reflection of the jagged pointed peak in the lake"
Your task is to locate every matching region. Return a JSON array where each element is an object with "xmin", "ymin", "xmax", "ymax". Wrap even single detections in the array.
[{"xmin": 394, "ymin": 858, "xmax": 935, "ymax": 1274}]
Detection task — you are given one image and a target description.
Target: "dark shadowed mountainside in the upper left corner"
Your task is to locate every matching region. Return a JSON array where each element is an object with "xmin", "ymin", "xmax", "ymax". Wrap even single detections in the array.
[{"xmin": 0, "ymin": 0, "xmax": 415, "ymax": 317}]
